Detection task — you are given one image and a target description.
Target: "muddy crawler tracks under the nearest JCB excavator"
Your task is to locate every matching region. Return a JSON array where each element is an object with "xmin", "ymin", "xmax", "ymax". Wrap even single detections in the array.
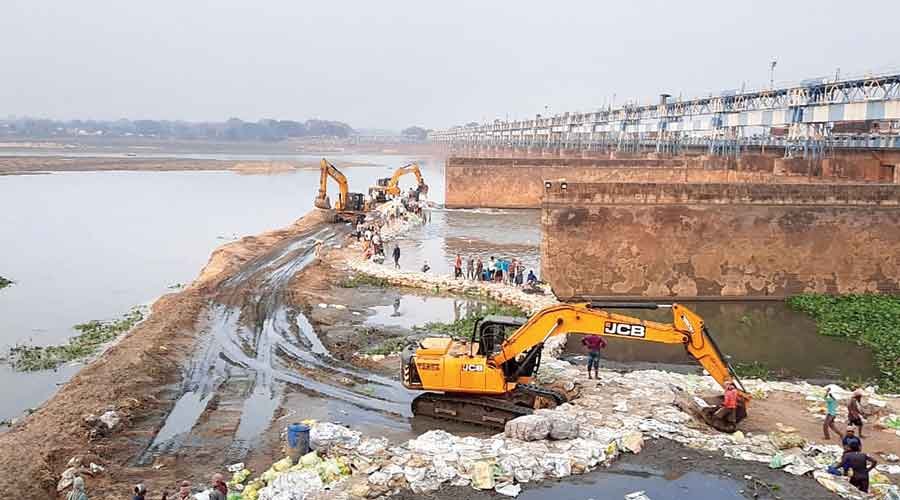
[{"xmin": 412, "ymin": 384, "xmax": 566, "ymax": 429}]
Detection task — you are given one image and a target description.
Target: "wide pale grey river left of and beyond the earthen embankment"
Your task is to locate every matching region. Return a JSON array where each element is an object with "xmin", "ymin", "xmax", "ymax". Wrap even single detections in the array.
[{"xmin": 0, "ymin": 155, "xmax": 444, "ymax": 420}]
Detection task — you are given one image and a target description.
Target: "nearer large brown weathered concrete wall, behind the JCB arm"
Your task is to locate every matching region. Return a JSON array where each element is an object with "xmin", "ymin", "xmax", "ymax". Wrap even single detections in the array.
[{"xmin": 541, "ymin": 182, "xmax": 900, "ymax": 299}]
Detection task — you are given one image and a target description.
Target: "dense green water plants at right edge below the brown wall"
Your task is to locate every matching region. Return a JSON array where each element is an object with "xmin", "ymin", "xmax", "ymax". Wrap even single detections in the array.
[{"xmin": 787, "ymin": 294, "xmax": 900, "ymax": 392}]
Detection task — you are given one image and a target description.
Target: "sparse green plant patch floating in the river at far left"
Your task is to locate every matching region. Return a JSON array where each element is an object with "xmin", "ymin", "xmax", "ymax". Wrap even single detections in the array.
[{"xmin": 9, "ymin": 308, "xmax": 144, "ymax": 371}]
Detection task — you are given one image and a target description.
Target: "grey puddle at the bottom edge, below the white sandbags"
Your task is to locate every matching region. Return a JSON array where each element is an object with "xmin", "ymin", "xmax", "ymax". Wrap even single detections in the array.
[{"xmin": 518, "ymin": 465, "xmax": 746, "ymax": 500}]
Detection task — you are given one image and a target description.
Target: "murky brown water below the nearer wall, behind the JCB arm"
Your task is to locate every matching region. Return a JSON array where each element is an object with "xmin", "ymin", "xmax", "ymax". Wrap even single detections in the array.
[{"xmin": 567, "ymin": 302, "xmax": 876, "ymax": 380}]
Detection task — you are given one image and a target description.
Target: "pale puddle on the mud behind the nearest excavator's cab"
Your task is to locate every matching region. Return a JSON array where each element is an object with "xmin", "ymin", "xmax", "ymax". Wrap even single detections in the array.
[{"xmin": 365, "ymin": 294, "xmax": 486, "ymax": 329}]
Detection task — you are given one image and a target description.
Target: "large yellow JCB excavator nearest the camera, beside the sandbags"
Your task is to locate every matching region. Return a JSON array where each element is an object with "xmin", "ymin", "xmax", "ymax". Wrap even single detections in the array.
[{"xmin": 401, "ymin": 302, "xmax": 750, "ymax": 432}]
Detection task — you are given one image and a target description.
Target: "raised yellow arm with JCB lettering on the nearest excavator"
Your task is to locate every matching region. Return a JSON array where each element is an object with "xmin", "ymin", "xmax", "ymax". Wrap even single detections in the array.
[{"xmin": 488, "ymin": 303, "xmax": 750, "ymax": 402}]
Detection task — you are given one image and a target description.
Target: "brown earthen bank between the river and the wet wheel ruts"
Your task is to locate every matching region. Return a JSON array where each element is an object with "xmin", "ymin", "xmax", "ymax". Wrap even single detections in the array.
[{"xmin": 0, "ymin": 210, "xmax": 329, "ymax": 500}]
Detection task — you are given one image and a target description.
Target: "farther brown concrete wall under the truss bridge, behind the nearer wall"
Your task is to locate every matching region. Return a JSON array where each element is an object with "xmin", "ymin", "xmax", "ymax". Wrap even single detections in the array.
[{"xmin": 445, "ymin": 155, "xmax": 900, "ymax": 208}]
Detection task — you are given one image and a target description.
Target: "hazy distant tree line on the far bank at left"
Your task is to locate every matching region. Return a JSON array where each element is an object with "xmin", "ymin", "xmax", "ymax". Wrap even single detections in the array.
[{"xmin": 0, "ymin": 118, "xmax": 354, "ymax": 141}]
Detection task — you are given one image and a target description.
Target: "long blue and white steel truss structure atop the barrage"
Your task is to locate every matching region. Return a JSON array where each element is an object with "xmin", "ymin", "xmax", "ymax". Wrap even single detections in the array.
[{"xmin": 429, "ymin": 73, "xmax": 900, "ymax": 157}]
